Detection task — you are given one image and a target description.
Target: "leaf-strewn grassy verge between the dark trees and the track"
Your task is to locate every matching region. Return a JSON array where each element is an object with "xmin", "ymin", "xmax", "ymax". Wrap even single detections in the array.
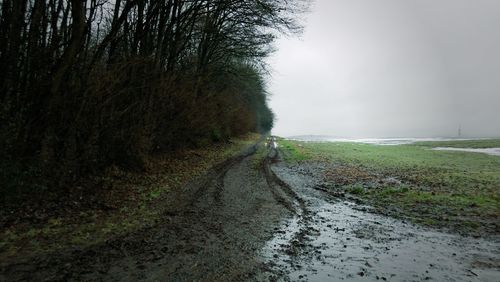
[{"xmin": 0, "ymin": 135, "xmax": 259, "ymax": 262}]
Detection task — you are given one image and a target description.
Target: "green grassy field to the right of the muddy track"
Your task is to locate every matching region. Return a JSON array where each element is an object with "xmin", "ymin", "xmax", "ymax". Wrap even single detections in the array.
[{"xmin": 280, "ymin": 140, "xmax": 500, "ymax": 234}]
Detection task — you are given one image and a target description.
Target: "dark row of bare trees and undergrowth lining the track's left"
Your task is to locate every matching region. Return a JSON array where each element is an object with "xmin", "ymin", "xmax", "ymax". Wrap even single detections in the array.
[{"xmin": 0, "ymin": 0, "xmax": 306, "ymax": 196}]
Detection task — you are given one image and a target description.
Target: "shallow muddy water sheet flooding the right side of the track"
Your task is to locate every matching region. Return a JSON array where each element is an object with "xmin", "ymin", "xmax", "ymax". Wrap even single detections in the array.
[{"xmin": 263, "ymin": 165, "xmax": 500, "ymax": 281}]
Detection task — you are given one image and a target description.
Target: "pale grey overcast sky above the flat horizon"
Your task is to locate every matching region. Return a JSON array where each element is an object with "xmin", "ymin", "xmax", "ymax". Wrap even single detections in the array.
[{"xmin": 269, "ymin": 0, "xmax": 500, "ymax": 137}]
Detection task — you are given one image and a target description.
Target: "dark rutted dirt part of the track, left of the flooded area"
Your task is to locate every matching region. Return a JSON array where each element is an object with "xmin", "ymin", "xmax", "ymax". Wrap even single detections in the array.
[{"xmin": 4, "ymin": 139, "xmax": 356, "ymax": 281}]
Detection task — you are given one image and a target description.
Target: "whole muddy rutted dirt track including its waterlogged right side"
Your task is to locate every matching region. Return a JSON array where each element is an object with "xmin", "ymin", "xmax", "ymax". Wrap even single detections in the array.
[{"xmin": 0, "ymin": 140, "xmax": 500, "ymax": 281}]
